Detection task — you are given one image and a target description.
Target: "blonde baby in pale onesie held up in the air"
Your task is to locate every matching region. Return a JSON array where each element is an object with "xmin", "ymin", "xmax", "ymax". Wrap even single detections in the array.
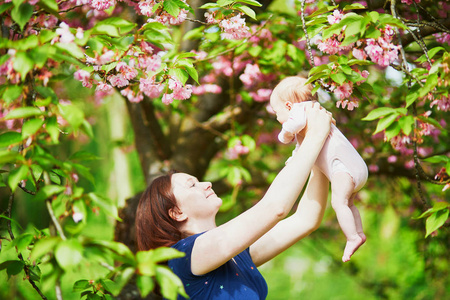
[{"xmin": 270, "ymin": 76, "xmax": 368, "ymax": 262}]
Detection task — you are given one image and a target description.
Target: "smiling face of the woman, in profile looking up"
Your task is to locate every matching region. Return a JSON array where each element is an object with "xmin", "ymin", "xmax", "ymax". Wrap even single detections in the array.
[{"xmin": 172, "ymin": 173, "xmax": 222, "ymax": 219}]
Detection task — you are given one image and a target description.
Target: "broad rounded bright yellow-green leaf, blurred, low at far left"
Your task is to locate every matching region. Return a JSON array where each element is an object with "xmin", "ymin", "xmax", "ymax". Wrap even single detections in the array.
[{"xmin": 55, "ymin": 240, "xmax": 83, "ymax": 272}]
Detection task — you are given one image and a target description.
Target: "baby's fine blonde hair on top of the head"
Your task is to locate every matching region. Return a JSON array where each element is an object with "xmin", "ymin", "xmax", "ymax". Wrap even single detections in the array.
[{"xmin": 270, "ymin": 76, "xmax": 317, "ymax": 103}]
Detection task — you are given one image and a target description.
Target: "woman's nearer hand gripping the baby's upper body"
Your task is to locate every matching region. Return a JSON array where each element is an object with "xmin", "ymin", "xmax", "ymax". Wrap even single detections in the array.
[{"xmin": 305, "ymin": 102, "xmax": 333, "ymax": 139}]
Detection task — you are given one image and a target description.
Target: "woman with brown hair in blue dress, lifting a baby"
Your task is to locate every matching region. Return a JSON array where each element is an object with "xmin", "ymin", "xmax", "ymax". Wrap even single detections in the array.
[{"xmin": 136, "ymin": 103, "xmax": 332, "ymax": 300}]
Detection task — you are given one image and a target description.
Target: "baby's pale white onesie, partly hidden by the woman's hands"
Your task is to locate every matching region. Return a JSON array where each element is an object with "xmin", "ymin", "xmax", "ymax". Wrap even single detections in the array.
[{"xmin": 278, "ymin": 101, "xmax": 368, "ymax": 192}]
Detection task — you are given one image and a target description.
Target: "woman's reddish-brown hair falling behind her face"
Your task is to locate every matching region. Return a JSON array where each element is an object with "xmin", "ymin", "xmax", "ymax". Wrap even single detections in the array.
[{"xmin": 136, "ymin": 171, "xmax": 182, "ymax": 251}]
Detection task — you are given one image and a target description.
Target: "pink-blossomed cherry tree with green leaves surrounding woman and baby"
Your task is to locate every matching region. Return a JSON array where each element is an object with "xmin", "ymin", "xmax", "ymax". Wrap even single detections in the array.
[{"xmin": 0, "ymin": 0, "xmax": 450, "ymax": 299}]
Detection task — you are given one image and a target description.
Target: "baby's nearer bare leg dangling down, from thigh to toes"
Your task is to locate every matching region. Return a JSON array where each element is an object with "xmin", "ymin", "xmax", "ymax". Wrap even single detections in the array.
[{"xmin": 331, "ymin": 172, "xmax": 365, "ymax": 262}]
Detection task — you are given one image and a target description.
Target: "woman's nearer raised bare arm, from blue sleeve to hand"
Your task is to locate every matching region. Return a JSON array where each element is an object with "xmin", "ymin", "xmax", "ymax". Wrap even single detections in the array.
[{"xmin": 191, "ymin": 103, "xmax": 331, "ymax": 275}]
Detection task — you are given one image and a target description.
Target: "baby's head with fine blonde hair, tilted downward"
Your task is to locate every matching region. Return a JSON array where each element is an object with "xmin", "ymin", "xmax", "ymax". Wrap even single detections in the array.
[{"xmin": 270, "ymin": 76, "xmax": 317, "ymax": 124}]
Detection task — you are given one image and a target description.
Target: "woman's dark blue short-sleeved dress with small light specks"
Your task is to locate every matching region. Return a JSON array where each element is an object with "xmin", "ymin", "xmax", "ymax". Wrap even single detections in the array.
[{"xmin": 168, "ymin": 233, "xmax": 267, "ymax": 300}]
